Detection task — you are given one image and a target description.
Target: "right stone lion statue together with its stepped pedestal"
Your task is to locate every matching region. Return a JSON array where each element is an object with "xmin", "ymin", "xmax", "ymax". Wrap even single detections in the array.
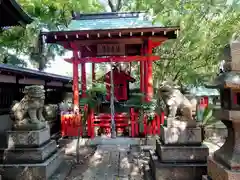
[{"xmin": 146, "ymin": 82, "xmax": 208, "ymax": 180}]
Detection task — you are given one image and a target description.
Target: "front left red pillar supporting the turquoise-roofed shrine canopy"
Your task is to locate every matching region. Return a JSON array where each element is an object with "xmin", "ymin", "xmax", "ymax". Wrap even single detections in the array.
[{"xmin": 71, "ymin": 44, "xmax": 79, "ymax": 114}]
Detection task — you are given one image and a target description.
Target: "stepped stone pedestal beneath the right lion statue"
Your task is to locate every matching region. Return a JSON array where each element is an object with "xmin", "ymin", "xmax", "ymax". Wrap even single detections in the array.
[{"xmin": 146, "ymin": 126, "xmax": 208, "ymax": 180}]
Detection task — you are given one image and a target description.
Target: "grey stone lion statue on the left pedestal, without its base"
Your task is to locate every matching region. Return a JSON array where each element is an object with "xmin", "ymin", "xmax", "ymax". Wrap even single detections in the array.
[{"xmin": 10, "ymin": 85, "xmax": 46, "ymax": 130}]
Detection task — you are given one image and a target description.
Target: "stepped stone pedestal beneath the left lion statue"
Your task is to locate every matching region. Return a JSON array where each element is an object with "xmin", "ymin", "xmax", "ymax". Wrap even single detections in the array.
[{"xmin": 0, "ymin": 128, "xmax": 67, "ymax": 180}]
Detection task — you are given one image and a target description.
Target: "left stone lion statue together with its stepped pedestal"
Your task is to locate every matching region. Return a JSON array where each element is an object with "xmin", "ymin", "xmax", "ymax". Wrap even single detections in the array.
[{"xmin": 0, "ymin": 86, "xmax": 68, "ymax": 180}]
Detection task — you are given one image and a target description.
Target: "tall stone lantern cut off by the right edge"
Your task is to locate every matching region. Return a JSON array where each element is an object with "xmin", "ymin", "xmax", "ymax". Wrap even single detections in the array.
[{"xmin": 203, "ymin": 41, "xmax": 240, "ymax": 180}]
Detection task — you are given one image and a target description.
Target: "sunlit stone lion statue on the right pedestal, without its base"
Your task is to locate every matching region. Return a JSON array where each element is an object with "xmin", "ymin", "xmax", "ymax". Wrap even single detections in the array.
[{"xmin": 158, "ymin": 81, "xmax": 196, "ymax": 126}]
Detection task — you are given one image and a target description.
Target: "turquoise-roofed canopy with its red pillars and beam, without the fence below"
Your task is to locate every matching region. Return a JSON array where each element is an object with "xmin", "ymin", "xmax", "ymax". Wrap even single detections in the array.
[{"xmin": 41, "ymin": 13, "xmax": 179, "ymax": 137}]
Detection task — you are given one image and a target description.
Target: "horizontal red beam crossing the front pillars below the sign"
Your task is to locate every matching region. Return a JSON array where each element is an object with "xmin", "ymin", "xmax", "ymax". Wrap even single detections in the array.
[{"xmin": 64, "ymin": 56, "xmax": 160, "ymax": 64}]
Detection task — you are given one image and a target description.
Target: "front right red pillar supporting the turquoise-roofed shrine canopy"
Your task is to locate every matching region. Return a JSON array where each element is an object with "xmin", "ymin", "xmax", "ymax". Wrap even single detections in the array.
[{"xmin": 145, "ymin": 40, "xmax": 153, "ymax": 101}]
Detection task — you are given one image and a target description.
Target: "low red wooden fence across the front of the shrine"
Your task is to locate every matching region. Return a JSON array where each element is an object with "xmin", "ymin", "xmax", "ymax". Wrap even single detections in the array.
[{"xmin": 61, "ymin": 108, "xmax": 164, "ymax": 138}]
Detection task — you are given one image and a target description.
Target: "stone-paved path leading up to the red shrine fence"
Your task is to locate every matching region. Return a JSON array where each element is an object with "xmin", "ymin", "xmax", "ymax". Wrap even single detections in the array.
[{"xmin": 67, "ymin": 145, "xmax": 143, "ymax": 180}]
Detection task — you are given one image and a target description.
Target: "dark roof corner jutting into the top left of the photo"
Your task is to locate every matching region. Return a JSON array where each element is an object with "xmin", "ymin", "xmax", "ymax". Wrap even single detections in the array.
[{"xmin": 0, "ymin": 0, "xmax": 33, "ymax": 27}]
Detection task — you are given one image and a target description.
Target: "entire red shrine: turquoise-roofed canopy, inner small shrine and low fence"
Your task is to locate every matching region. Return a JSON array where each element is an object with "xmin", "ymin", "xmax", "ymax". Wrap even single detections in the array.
[{"xmin": 41, "ymin": 12, "xmax": 179, "ymax": 137}]
